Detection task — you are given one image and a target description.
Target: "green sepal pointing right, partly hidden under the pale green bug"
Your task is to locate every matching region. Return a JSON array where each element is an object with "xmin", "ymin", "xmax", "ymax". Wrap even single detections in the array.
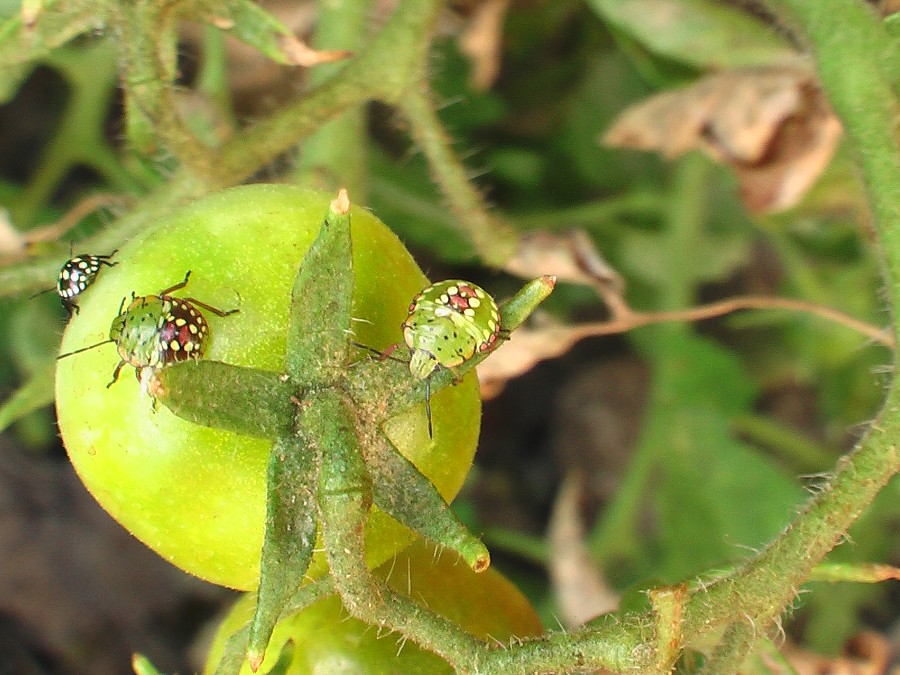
[{"xmin": 347, "ymin": 276, "xmax": 556, "ymax": 423}]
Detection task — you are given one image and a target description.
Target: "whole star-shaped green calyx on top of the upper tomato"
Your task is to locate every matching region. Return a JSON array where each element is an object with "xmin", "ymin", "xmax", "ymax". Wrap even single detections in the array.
[{"xmin": 150, "ymin": 193, "xmax": 552, "ymax": 663}]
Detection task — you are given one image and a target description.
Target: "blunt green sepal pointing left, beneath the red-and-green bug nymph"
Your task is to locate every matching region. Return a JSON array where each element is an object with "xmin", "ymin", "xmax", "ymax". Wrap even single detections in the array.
[{"xmin": 151, "ymin": 361, "xmax": 297, "ymax": 440}]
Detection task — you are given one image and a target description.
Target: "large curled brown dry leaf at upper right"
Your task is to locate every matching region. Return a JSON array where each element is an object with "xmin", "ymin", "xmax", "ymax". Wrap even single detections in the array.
[{"xmin": 603, "ymin": 67, "xmax": 841, "ymax": 213}]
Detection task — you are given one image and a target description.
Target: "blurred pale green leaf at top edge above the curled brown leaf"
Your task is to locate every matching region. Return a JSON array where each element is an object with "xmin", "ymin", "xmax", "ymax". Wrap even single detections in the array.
[{"xmin": 588, "ymin": 0, "xmax": 795, "ymax": 69}]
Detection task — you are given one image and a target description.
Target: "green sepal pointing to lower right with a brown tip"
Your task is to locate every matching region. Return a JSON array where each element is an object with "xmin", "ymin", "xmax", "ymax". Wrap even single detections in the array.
[{"xmin": 366, "ymin": 433, "xmax": 491, "ymax": 572}]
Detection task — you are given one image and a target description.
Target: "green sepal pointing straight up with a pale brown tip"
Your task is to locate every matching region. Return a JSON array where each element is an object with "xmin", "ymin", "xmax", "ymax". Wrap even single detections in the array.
[{"xmin": 284, "ymin": 191, "xmax": 354, "ymax": 385}]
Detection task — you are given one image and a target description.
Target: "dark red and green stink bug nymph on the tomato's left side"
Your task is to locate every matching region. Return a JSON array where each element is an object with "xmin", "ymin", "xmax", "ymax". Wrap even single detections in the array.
[{"xmin": 57, "ymin": 271, "xmax": 238, "ymax": 387}]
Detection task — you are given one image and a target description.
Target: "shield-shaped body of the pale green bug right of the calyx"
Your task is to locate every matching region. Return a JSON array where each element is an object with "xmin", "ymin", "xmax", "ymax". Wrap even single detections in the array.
[{"xmin": 403, "ymin": 279, "xmax": 500, "ymax": 379}]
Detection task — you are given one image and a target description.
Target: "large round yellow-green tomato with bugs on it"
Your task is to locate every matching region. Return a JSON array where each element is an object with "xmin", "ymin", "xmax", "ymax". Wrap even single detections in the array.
[{"xmin": 56, "ymin": 185, "xmax": 481, "ymax": 590}]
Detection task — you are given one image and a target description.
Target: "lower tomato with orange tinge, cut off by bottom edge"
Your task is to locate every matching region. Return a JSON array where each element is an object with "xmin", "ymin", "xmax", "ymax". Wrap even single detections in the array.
[{"xmin": 203, "ymin": 540, "xmax": 542, "ymax": 675}]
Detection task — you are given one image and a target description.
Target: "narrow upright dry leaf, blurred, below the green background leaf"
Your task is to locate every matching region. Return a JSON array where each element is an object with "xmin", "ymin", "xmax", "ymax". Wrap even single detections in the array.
[{"xmin": 547, "ymin": 474, "xmax": 619, "ymax": 628}]
